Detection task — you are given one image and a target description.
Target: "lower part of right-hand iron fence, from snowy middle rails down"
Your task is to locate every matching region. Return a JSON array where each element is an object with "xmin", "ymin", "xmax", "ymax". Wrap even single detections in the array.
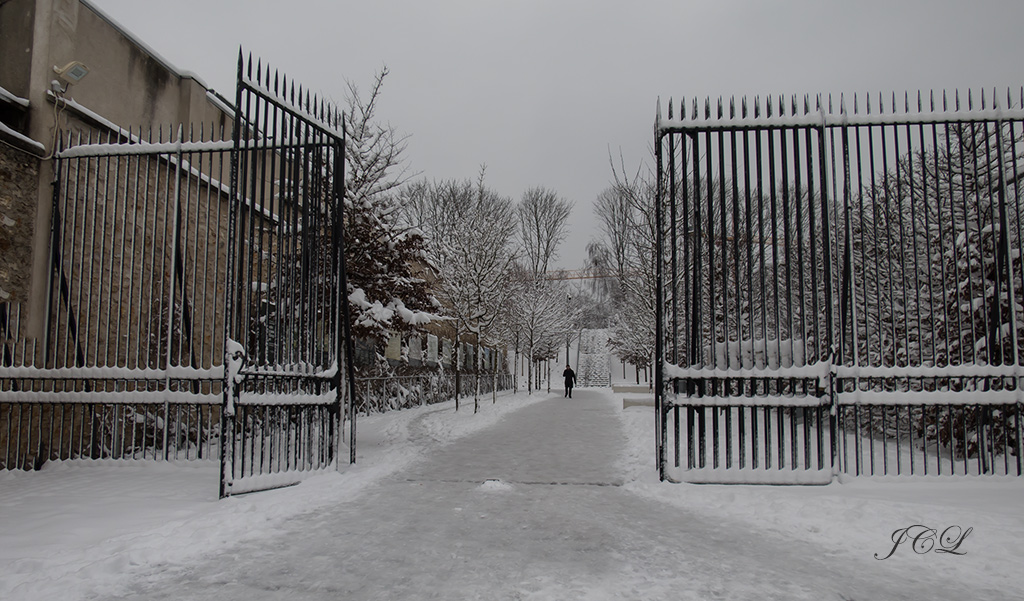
[{"xmin": 660, "ymin": 368, "xmax": 1024, "ymax": 484}]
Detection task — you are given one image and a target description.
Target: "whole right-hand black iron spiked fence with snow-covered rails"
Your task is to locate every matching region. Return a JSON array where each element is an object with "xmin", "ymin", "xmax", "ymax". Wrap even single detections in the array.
[{"xmin": 655, "ymin": 90, "xmax": 1024, "ymax": 481}]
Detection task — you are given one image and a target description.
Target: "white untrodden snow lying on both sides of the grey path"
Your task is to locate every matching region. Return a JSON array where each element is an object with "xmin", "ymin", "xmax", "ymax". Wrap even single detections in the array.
[{"xmin": 0, "ymin": 390, "xmax": 1024, "ymax": 601}]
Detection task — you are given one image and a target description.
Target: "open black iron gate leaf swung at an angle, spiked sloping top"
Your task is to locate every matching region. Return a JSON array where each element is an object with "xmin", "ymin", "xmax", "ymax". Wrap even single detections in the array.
[{"xmin": 220, "ymin": 54, "xmax": 355, "ymax": 497}]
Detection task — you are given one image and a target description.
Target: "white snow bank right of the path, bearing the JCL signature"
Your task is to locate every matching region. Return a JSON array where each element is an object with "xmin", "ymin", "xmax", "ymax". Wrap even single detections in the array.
[{"xmin": 622, "ymin": 395, "xmax": 1024, "ymax": 598}]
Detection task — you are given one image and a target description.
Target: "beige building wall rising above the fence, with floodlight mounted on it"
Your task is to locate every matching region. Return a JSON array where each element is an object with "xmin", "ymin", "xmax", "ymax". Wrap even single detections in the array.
[{"xmin": 0, "ymin": 0, "xmax": 233, "ymax": 344}]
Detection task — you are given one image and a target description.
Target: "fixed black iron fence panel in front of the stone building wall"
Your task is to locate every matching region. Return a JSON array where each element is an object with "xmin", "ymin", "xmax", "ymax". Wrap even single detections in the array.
[{"xmin": 0, "ymin": 121, "xmax": 230, "ymax": 469}]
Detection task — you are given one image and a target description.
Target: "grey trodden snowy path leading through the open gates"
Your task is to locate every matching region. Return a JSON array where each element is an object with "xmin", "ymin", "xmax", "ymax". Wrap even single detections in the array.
[{"xmin": 103, "ymin": 390, "xmax": 987, "ymax": 601}]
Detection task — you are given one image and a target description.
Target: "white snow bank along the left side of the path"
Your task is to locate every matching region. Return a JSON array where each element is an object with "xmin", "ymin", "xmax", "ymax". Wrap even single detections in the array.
[{"xmin": 0, "ymin": 393, "xmax": 545, "ymax": 601}]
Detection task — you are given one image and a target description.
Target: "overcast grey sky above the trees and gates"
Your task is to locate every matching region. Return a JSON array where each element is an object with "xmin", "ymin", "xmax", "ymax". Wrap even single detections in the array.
[{"xmin": 92, "ymin": 0, "xmax": 1024, "ymax": 268}]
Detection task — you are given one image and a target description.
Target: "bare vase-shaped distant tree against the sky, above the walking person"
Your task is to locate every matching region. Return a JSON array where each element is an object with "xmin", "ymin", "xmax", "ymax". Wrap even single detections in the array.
[{"xmin": 517, "ymin": 187, "xmax": 572, "ymax": 276}]
